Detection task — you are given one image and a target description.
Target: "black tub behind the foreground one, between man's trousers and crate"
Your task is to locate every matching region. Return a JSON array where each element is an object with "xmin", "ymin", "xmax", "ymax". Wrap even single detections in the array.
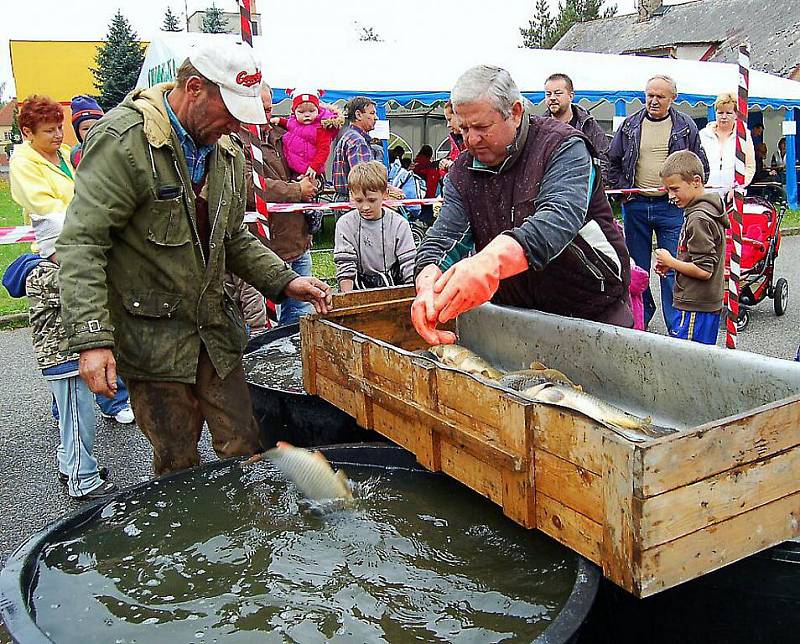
[{"xmin": 245, "ymin": 324, "xmax": 381, "ymax": 447}]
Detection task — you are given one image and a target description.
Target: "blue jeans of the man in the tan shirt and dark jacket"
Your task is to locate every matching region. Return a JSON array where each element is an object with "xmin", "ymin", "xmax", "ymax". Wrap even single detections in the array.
[{"xmin": 622, "ymin": 197, "xmax": 683, "ymax": 331}]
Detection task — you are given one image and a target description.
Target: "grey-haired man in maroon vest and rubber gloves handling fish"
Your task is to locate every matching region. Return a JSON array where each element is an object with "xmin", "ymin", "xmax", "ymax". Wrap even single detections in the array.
[{"xmin": 411, "ymin": 65, "xmax": 633, "ymax": 344}]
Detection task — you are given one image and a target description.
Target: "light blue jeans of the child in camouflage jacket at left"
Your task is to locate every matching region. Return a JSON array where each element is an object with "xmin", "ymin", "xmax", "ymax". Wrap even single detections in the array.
[{"xmin": 47, "ymin": 376, "xmax": 103, "ymax": 496}]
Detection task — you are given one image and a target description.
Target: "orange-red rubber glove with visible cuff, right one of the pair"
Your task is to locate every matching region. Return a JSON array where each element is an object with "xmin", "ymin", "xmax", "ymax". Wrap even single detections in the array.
[{"xmin": 434, "ymin": 235, "xmax": 528, "ymax": 324}]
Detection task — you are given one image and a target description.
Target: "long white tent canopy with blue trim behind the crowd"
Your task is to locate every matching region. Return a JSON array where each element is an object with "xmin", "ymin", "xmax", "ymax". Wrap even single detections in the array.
[{"xmin": 138, "ymin": 33, "xmax": 800, "ymax": 109}]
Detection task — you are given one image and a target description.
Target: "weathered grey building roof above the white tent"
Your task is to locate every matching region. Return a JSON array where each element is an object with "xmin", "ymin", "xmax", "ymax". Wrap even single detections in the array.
[{"xmin": 555, "ymin": 0, "xmax": 800, "ymax": 78}]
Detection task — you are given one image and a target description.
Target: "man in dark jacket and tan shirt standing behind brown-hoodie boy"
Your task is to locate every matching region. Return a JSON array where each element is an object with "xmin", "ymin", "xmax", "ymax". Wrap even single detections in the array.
[{"xmin": 608, "ymin": 76, "xmax": 708, "ymax": 330}]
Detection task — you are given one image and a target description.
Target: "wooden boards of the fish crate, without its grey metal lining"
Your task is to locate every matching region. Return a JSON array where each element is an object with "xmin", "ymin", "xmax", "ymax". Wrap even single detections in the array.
[{"xmin": 301, "ymin": 288, "xmax": 800, "ymax": 597}]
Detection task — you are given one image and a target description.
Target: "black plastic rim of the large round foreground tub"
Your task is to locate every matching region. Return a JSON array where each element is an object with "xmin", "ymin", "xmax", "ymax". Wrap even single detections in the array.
[{"xmin": 0, "ymin": 443, "xmax": 601, "ymax": 644}]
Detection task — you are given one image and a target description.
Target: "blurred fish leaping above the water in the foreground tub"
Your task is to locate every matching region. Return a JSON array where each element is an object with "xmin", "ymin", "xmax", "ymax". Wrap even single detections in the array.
[{"xmin": 246, "ymin": 441, "xmax": 353, "ymax": 501}]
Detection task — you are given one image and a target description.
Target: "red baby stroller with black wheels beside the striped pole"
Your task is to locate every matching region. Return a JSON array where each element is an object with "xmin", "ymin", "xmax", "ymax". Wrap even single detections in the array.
[{"xmin": 725, "ymin": 197, "xmax": 789, "ymax": 331}]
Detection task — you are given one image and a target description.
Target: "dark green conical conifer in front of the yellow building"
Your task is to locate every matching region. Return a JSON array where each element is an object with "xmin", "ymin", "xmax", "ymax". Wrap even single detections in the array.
[{"xmin": 91, "ymin": 10, "xmax": 144, "ymax": 110}]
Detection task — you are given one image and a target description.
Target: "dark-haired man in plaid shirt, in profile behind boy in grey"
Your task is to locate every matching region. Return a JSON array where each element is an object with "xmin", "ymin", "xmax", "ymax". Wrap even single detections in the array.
[{"xmin": 333, "ymin": 96, "xmax": 378, "ymax": 201}]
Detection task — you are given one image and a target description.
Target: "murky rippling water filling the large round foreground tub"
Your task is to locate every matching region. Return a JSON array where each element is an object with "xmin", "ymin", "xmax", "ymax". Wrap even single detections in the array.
[{"xmin": 32, "ymin": 463, "xmax": 577, "ymax": 644}]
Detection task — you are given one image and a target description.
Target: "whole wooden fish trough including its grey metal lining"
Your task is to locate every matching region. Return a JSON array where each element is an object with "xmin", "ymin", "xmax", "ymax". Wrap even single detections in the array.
[{"xmin": 301, "ymin": 288, "xmax": 800, "ymax": 597}]
